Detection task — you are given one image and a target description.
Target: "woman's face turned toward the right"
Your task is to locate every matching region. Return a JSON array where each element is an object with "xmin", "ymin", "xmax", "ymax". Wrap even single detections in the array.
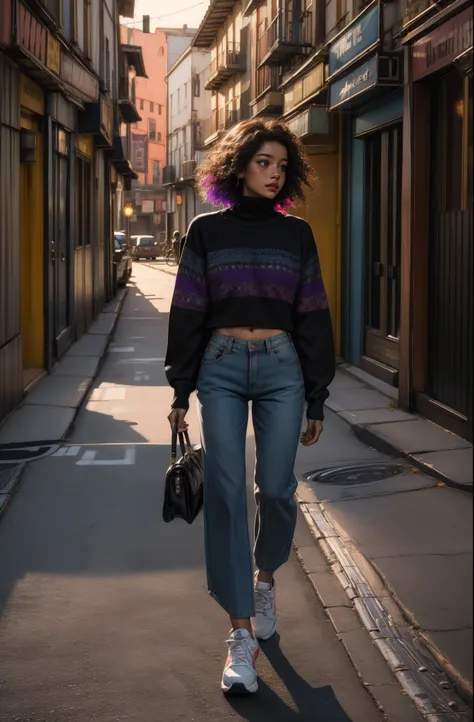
[{"xmin": 239, "ymin": 141, "xmax": 288, "ymax": 199}]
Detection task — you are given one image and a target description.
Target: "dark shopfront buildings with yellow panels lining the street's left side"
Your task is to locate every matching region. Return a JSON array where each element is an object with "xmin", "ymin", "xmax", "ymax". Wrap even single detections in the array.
[{"xmin": 0, "ymin": 0, "xmax": 143, "ymax": 419}]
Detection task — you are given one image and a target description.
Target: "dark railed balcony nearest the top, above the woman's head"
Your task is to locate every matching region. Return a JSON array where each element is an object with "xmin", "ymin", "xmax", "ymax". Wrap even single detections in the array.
[{"xmin": 257, "ymin": 6, "xmax": 313, "ymax": 67}]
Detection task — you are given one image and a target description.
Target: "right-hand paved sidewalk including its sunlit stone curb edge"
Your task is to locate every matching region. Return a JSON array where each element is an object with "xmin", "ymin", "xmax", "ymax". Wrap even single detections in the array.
[{"xmin": 296, "ymin": 367, "xmax": 473, "ymax": 722}]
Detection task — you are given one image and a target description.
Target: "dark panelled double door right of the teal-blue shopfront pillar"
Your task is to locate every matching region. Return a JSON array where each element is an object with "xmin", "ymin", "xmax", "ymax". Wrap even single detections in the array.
[{"xmin": 361, "ymin": 124, "xmax": 402, "ymax": 385}]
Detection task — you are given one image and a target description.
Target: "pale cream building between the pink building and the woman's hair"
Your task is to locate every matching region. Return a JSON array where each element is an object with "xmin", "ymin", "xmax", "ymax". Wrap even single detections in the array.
[{"xmin": 165, "ymin": 46, "xmax": 211, "ymax": 233}]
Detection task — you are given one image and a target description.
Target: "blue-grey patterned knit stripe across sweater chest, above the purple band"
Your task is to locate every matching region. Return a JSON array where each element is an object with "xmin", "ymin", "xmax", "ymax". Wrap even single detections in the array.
[{"xmin": 207, "ymin": 248, "xmax": 301, "ymax": 274}]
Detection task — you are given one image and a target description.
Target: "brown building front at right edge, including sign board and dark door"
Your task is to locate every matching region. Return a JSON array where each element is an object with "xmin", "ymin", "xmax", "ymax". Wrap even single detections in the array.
[{"xmin": 400, "ymin": 0, "xmax": 474, "ymax": 441}]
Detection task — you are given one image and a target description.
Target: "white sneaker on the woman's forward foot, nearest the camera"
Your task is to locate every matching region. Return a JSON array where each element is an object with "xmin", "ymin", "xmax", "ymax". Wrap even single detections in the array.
[{"xmin": 221, "ymin": 629, "xmax": 260, "ymax": 694}]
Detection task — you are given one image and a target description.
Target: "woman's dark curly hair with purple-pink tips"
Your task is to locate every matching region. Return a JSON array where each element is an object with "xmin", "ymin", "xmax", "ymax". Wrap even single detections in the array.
[{"xmin": 196, "ymin": 118, "xmax": 313, "ymax": 210}]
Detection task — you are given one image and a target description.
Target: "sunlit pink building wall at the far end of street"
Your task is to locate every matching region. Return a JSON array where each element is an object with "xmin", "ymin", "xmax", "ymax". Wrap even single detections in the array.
[{"xmin": 120, "ymin": 26, "xmax": 167, "ymax": 185}]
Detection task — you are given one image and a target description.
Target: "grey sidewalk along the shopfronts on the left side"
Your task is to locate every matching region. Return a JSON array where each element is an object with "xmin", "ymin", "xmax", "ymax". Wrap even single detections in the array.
[{"xmin": 0, "ymin": 289, "xmax": 127, "ymax": 448}]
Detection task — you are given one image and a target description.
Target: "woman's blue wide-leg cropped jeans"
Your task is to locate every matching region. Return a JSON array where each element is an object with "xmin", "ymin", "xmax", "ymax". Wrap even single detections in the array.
[{"xmin": 197, "ymin": 333, "xmax": 304, "ymax": 619}]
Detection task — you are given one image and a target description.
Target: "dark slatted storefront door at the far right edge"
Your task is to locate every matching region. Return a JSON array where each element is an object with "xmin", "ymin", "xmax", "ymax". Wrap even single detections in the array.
[{"xmin": 426, "ymin": 70, "xmax": 473, "ymax": 434}]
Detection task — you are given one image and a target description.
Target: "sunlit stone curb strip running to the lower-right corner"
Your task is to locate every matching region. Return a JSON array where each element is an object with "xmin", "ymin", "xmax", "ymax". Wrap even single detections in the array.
[{"xmin": 297, "ymin": 495, "xmax": 472, "ymax": 722}]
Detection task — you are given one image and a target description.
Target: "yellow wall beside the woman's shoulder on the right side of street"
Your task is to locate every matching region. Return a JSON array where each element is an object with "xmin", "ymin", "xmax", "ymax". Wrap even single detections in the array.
[{"xmin": 294, "ymin": 152, "xmax": 341, "ymax": 356}]
